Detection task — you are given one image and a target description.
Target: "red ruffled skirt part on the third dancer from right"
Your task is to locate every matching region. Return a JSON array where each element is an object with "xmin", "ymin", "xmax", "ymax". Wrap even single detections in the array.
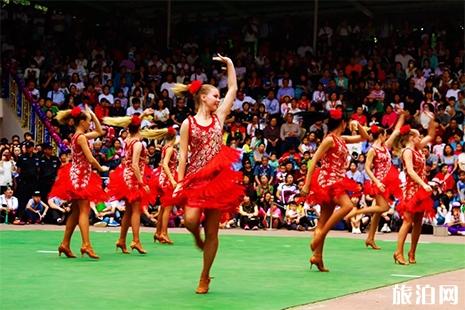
[{"xmin": 306, "ymin": 169, "xmax": 361, "ymax": 206}]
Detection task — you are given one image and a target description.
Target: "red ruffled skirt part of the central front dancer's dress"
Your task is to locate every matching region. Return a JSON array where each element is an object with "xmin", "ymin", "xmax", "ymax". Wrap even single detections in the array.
[{"xmin": 166, "ymin": 146, "xmax": 244, "ymax": 211}]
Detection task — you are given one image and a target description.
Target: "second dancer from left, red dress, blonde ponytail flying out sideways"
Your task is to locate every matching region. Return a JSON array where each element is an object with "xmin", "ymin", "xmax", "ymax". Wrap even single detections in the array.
[{"xmin": 103, "ymin": 109, "xmax": 167, "ymax": 254}]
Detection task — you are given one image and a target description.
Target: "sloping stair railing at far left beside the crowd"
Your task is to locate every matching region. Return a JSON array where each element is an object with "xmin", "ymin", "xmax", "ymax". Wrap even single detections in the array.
[{"xmin": 9, "ymin": 76, "xmax": 68, "ymax": 151}]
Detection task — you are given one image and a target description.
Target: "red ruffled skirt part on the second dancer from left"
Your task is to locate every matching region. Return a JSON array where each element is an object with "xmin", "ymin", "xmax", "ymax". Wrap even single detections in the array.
[{"xmin": 107, "ymin": 165, "xmax": 157, "ymax": 208}]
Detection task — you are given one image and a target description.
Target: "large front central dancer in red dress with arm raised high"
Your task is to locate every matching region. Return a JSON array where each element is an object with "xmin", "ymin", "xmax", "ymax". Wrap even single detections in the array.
[{"xmin": 172, "ymin": 55, "xmax": 243, "ymax": 294}]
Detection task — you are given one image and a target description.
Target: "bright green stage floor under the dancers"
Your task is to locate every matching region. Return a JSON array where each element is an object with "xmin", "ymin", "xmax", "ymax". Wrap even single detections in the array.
[{"xmin": 0, "ymin": 230, "xmax": 465, "ymax": 309}]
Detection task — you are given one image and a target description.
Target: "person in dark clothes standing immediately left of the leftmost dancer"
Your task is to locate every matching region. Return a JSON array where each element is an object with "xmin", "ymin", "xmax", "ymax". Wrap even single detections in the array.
[{"xmin": 39, "ymin": 143, "xmax": 61, "ymax": 201}]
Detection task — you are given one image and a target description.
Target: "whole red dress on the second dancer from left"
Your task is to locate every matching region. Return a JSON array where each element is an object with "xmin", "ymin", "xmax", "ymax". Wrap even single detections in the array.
[{"xmin": 108, "ymin": 139, "xmax": 156, "ymax": 208}]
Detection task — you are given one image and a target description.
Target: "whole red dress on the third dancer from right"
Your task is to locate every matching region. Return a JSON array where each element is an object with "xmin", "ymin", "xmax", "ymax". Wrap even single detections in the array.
[{"xmin": 307, "ymin": 134, "xmax": 361, "ymax": 205}]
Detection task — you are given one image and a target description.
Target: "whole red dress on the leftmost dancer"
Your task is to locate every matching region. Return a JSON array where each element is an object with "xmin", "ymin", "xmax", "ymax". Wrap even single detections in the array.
[{"xmin": 48, "ymin": 134, "xmax": 108, "ymax": 203}]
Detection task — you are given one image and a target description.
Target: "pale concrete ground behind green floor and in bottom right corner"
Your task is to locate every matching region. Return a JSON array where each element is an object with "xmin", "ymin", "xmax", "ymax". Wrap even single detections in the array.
[{"xmin": 0, "ymin": 224, "xmax": 465, "ymax": 310}]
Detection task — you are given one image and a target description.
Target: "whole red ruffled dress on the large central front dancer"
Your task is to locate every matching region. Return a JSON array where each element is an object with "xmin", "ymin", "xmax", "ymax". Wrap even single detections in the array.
[{"xmin": 172, "ymin": 114, "xmax": 244, "ymax": 211}]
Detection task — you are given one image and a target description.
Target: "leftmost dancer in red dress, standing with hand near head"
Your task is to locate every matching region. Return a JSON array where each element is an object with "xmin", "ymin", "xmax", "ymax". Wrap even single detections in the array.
[{"xmin": 49, "ymin": 106, "xmax": 108, "ymax": 259}]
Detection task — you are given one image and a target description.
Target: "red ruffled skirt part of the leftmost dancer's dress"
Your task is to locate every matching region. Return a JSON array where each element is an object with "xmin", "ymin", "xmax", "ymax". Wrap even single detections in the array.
[{"xmin": 48, "ymin": 163, "xmax": 108, "ymax": 203}]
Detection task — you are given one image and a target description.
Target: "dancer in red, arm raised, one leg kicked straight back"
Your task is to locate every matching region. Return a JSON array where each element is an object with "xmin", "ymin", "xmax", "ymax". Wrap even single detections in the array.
[{"xmin": 345, "ymin": 113, "xmax": 405, "ymax": 250}]
